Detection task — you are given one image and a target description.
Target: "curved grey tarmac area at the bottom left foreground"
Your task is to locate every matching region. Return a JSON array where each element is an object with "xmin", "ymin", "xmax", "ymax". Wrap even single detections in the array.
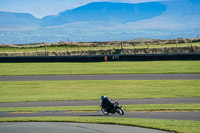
[{"xmin": 0, "ymin": 122, "xmax": 169, "ymax": 133}]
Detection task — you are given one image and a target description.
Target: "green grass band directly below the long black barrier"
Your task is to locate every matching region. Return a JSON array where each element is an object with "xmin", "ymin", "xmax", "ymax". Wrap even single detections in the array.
[{"xmin": 0, "ymin": 61, "xmax": 200, "ymax": 75}]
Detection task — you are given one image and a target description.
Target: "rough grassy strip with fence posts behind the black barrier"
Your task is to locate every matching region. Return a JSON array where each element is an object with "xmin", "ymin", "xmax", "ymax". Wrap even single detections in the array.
[{"xmin": 0, "ymin": 42, "xmax": 200, "ymax": 56}]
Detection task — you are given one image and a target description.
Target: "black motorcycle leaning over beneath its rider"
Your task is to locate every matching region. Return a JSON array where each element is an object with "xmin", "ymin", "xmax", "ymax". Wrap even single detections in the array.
[{"xmin": 101, "ymin": 102, "xmax": 124, "ymax": 115}]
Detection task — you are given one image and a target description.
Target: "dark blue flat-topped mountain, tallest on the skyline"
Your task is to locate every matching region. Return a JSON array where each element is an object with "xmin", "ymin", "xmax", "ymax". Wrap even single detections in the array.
[{"xmin": 42, "ymin": 2, "xmax": 166, "ymax": 26}]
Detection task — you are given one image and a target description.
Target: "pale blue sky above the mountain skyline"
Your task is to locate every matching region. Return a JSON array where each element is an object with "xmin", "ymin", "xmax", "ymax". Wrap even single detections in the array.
[{"xmin": 0, "ymin": 0, "xmax": 169, "ymax": 18}]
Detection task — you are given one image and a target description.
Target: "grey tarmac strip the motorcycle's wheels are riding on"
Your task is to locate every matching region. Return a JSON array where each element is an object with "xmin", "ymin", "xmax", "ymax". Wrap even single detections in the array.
[{"xmin": 0, "ymin": 111, "xmax": 200, "ymax": 121}]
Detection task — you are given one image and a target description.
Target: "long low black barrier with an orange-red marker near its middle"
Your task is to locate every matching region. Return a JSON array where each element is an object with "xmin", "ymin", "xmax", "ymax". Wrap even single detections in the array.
[{"xmin": 0, "ymin": 53, "xmax": 200, "ymax": 63}]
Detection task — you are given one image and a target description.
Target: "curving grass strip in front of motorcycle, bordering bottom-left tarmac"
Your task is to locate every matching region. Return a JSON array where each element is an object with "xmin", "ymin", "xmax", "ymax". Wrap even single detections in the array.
[{"xmin": 0, "ymin": 116, "xmax": 200, "ymax": 133}]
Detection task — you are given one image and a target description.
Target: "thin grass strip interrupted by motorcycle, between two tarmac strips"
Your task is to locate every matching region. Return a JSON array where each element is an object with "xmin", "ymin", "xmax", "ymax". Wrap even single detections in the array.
[{"xmin": 0, "ymin": 103, "xmax": 200, "ymax": 112}]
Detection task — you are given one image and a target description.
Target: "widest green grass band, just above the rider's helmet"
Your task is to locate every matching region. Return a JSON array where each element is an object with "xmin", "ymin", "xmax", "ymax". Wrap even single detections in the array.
[{"xmin": 0, "ymin": 80, "xmax": 200, "ymax": 102}]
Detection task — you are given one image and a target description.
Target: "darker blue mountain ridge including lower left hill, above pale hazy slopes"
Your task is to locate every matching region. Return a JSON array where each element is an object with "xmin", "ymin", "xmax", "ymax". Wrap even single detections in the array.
[{"xmin": 0, "ymin": 2, "xmax": 166, "ymax": 30}]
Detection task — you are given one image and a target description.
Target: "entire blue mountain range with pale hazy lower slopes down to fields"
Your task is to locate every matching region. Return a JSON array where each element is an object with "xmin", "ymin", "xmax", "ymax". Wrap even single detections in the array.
[{"xmin": 0, "ymin": 0, "xmax": 200, "ymax": 44}]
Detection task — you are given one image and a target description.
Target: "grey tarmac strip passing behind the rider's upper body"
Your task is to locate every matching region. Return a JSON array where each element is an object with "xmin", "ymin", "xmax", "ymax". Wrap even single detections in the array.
[{"xmin": 0, "ymin": 97, "xmax": 200, "ymax": 107}]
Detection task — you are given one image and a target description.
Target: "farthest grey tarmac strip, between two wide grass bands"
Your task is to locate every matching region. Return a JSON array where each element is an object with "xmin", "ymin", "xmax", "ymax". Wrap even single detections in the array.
[{"xmin": 0, "ymin": 74, "xmax": 200, "ymax": 81}]
